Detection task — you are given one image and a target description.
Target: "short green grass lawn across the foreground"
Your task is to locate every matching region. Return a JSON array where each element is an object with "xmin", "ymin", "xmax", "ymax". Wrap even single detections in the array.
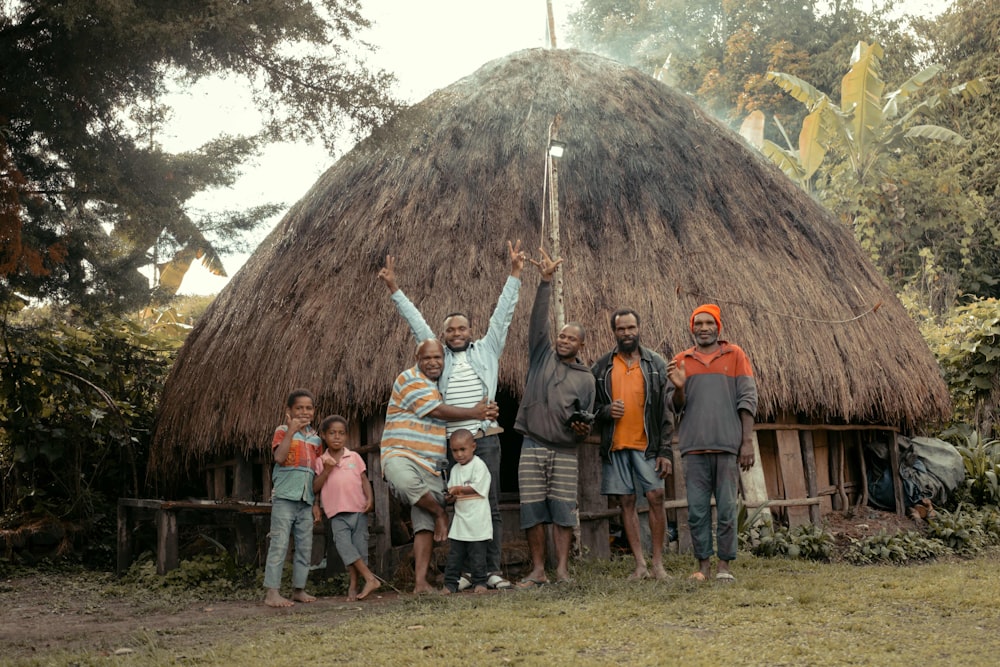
[{"xmin": 13, "ymin": 550, "xmax": 1000, "ymax": 667}]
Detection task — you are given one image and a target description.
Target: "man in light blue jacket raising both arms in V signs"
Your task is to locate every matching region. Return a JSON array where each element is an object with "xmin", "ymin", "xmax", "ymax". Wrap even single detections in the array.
[{"xmin": 378, "ymin": 241, "xmax": 526, "ymax": 588}]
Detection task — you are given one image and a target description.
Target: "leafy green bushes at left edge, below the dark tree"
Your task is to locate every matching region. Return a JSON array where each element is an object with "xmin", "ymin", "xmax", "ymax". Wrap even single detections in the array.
[{"xmin": 0, "ymin": 308, "xmax": 190, "ymax": 558}]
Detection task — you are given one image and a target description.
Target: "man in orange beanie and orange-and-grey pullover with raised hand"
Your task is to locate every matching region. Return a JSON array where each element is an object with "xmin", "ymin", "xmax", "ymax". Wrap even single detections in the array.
[{"xmin": 667, "ymin": 304, "xmax": 757, "ymax": 582}]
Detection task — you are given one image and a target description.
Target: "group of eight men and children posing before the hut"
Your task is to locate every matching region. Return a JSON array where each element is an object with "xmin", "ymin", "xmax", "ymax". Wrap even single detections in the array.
[{"xmin": 264, "ymin": 241, "xmax": 757, "ymax": 606}]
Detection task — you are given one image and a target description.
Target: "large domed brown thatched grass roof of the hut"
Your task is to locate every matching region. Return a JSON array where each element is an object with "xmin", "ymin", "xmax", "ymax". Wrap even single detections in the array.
[{"xmin": 153, "ymin": 50, "xmax": 950, "ymax": 470}]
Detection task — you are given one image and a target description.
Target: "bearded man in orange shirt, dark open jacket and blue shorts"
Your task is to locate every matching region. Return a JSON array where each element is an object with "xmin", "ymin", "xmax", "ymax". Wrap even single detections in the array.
[{"xmin": 591, "ymin": 309, "xmax": 674, "ymax": 579}]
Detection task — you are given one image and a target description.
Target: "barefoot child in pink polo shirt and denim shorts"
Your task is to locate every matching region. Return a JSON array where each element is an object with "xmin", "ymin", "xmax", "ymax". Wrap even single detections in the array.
[{"xmin": 313, "ymin": 415, "xmax": 380, "ymax": 602}]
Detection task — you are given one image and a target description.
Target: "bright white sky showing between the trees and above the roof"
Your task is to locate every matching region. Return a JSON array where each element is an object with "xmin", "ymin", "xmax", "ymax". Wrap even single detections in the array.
[{"xmin": 174, "ymin": 0, "xmax": 950, "ymax": 294}]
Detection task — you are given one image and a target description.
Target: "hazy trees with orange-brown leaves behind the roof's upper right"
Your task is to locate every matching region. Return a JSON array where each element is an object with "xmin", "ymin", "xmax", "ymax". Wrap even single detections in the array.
[{"xmin": 570, "ymin": 0, "xmax": 915, "ymax": 128}]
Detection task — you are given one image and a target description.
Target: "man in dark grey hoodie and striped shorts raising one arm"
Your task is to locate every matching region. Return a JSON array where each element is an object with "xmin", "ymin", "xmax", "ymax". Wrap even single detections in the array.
[{"xmin": 514, "ymin": 250, "xmax": 595, "ymax": 588}]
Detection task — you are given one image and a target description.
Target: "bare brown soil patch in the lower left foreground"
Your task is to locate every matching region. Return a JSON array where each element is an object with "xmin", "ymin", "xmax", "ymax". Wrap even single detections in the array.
[{"xmin": 0, "ymin": 573, "xmax": 398, "ymax": 662}]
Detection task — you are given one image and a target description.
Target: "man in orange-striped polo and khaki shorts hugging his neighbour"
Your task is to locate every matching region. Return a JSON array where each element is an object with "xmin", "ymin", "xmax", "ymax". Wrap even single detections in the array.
[{"xmin": 381, "ymin": 338, "xmax": 497, "ymax": 593}]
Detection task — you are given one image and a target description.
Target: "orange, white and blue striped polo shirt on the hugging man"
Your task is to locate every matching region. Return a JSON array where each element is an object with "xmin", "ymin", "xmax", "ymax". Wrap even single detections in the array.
[{"xmin": 381, "ymin": 366, "xmax": 447, "ymax": 472}]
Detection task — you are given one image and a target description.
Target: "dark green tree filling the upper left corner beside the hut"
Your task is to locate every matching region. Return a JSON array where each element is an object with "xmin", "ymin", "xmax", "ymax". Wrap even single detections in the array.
[{"xmin": 0, "ymin": 0, "xmax": 394, "ymax": 310}]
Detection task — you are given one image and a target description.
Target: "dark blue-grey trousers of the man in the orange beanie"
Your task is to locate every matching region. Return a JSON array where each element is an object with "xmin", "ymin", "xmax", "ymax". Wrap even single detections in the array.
[{"xmin": 684, "ymin": 452, "xmax": 740, "ymax": 562}]
